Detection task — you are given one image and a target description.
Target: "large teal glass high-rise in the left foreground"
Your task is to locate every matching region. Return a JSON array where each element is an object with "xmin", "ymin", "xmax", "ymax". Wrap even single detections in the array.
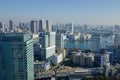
[{"xmin": 0, "ymin": 33, "xmax": 34, "ymax": 80}]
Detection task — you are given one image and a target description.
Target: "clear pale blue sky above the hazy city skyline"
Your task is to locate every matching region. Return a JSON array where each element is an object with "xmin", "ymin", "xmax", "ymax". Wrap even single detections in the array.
[{"xmin": 0, "ymin": 0, "xmax": 120, "ymax": 25}]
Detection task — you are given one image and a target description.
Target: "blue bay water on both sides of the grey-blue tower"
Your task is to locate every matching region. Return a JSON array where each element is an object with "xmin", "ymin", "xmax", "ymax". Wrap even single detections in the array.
[{"xmin": 64, "ymin": 38, "xmax": 114, "ymax": 50}]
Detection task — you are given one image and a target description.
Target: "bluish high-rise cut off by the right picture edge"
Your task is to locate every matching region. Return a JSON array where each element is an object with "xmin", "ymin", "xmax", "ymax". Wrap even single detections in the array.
[{"xmin": 114, "ymin": 35, "xmax": 120, "ymax": 63}]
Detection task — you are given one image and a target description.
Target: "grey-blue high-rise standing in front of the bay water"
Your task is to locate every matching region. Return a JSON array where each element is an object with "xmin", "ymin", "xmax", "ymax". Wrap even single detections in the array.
[{"xmin": 91, "ymin": 33, "xmax": 101, "ymax": 52}]
